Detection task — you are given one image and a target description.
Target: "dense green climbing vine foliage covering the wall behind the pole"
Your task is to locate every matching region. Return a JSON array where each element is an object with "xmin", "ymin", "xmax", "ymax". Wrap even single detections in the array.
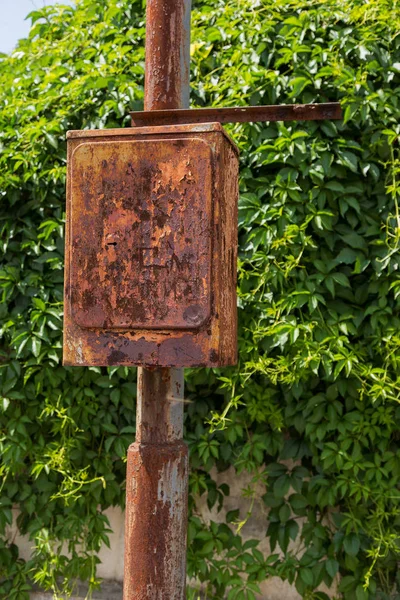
[{"xmin": 0, "ymin": 0, "xmax": 400, "ymax": 600}]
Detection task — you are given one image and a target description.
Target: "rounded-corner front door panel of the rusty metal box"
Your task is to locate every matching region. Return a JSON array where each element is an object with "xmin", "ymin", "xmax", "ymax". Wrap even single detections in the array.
[{"xmin": 71, "ymin": 138, "xmax": 212, "ymax": 330}]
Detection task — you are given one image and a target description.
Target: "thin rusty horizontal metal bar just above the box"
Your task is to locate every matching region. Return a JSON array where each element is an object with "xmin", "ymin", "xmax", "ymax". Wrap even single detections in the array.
[{"xmin": 130, "ymin": 102, "xmax": 343, "ymax": 127}]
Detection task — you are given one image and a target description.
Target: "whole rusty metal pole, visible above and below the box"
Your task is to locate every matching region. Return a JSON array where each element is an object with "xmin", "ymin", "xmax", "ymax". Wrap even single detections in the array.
[{"xmin": 124, "ymin": 0, "xmax": 191, "ymax": 600}]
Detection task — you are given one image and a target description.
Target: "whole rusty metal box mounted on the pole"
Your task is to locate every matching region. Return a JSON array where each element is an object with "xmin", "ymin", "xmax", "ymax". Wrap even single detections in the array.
[{"xmin": 64, "ymin": 123, "xmax": 238, "ymax": 367}]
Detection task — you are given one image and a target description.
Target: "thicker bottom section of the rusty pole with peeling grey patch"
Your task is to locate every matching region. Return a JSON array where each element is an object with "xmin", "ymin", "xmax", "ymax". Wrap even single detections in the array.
[{"xmin": 124, "ymin": 442, "xmax": 188, "ymax": 600}]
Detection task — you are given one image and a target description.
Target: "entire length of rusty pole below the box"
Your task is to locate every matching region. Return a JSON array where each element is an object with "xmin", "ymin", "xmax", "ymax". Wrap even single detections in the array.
[{"xmin": 124, "ymin": 368, "xmax": 189, "ymax": 600}]
